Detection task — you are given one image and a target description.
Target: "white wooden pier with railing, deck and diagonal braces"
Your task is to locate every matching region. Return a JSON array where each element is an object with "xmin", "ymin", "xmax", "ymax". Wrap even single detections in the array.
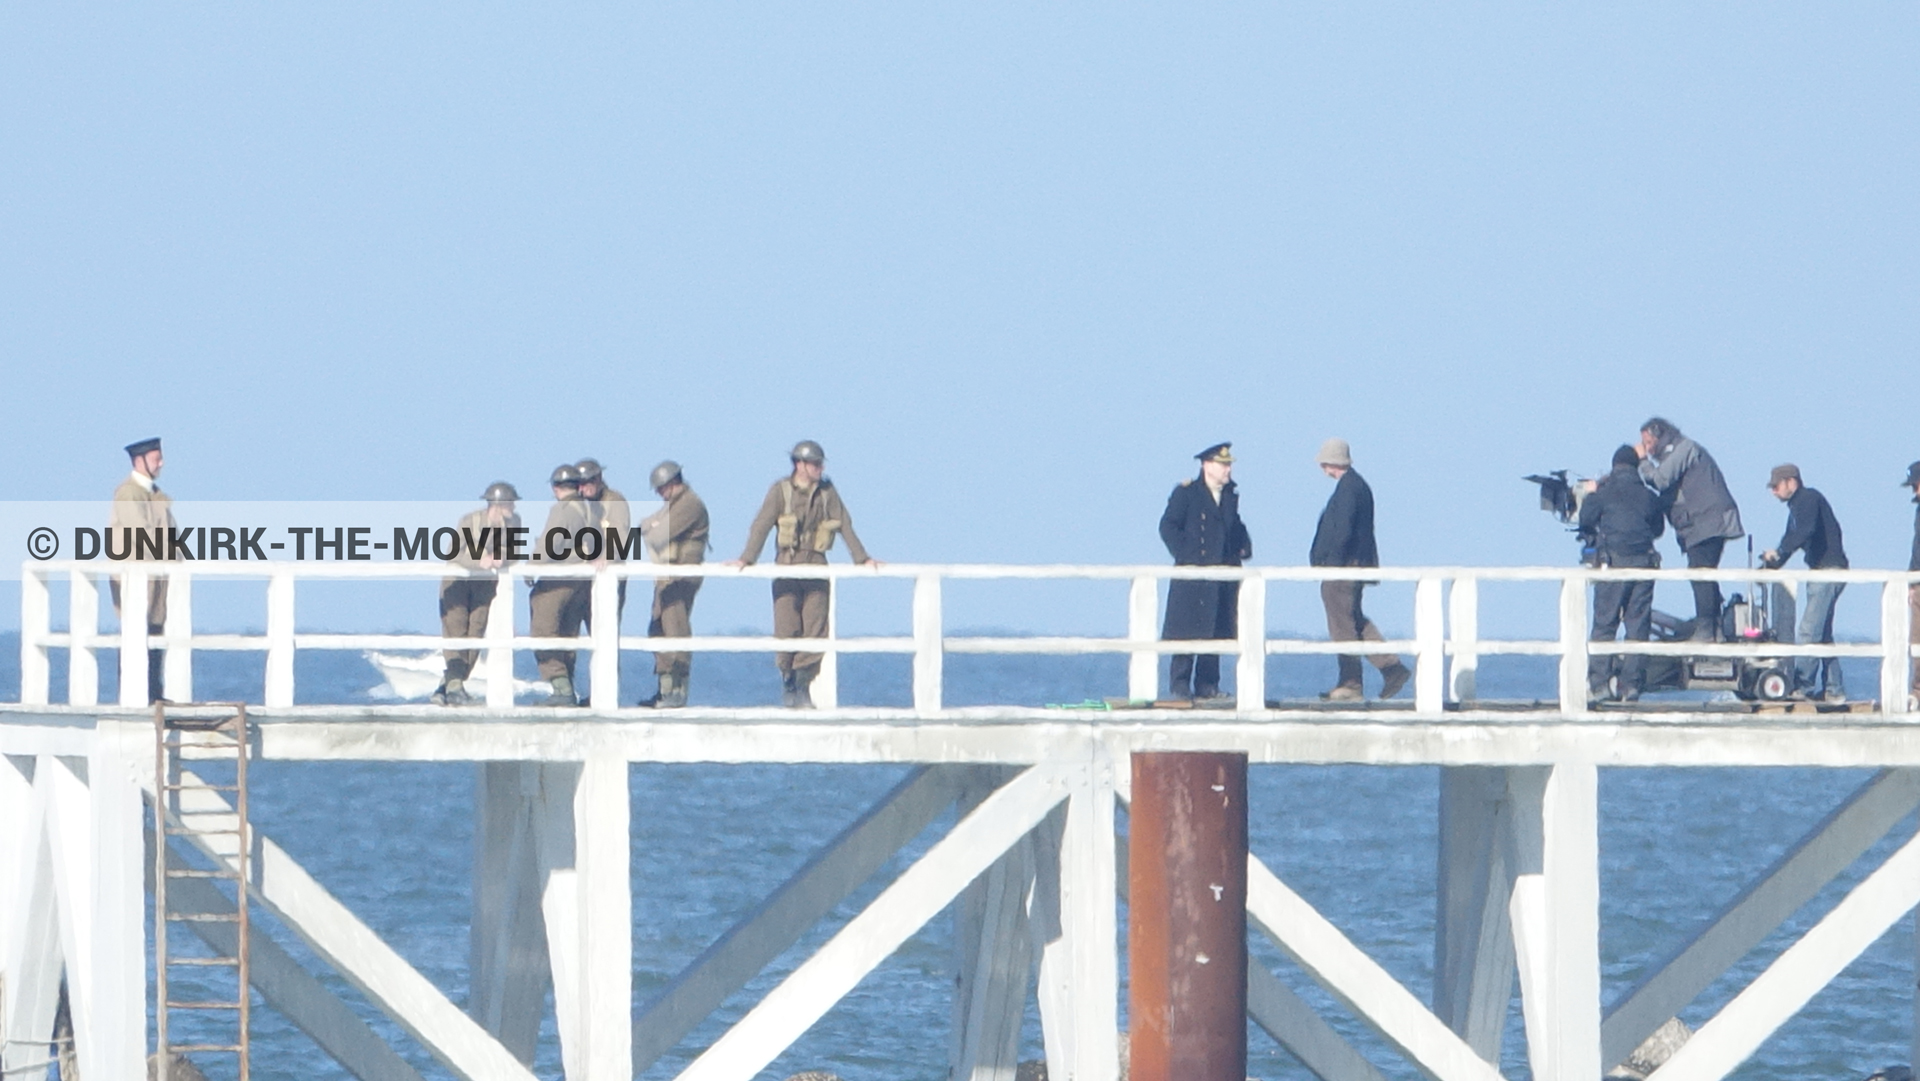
[{"xmin": 0, "ymin": 563, "xmax": 1920, "ymax": 1081}]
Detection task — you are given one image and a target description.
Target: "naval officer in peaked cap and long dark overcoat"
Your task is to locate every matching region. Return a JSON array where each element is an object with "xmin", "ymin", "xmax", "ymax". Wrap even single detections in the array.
[{"xmin": 1160, "ymin": 444, "xmax": 1254, "ymax": 701}]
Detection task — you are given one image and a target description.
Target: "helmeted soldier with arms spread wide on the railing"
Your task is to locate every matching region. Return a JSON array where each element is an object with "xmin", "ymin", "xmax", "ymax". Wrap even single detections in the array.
[{"xmin": 730, "ymin": 440, "xmax": 879, "ymax": 709}]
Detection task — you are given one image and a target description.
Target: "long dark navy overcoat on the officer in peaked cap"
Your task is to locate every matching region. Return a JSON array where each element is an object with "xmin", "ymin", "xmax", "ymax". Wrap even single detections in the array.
[{"xmin": 1160, "ymin": 480, "xmax": 1254, "ymax": 639}]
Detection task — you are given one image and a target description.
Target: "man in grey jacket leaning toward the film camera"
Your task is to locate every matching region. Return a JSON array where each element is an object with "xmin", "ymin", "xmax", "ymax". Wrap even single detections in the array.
[{"xmin": 1640, "ymin": 417, "xmax": 1747, "ymax": 641}]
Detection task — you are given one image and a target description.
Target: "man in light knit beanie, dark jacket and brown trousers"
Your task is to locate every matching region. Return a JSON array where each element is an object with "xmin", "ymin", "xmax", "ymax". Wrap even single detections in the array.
[{"xmin": 1308, "ymin": 440, "xmax": 1413, "ymax": 703}]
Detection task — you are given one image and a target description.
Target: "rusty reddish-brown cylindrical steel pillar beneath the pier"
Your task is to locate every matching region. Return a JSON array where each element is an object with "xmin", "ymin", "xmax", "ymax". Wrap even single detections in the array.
[{"xmin": 1127, "ymin": 753, "xmax": 1246, "ymax": 1081}]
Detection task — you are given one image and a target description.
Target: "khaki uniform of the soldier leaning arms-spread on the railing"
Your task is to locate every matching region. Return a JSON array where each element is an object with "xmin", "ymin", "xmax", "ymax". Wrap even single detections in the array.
[{"xmin": 739, "ymin": 476, "xmax": 868, "ymax": 676}]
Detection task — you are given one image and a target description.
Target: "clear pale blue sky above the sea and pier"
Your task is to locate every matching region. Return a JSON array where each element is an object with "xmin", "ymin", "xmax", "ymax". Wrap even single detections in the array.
[{"xmin": 0, "ymin": 4, "xmax": 1920, "ymax": 626}]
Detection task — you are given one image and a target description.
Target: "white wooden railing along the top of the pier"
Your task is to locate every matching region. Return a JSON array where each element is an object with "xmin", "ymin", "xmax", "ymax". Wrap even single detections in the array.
[{"xmin": 21, "ymin": 561, "xmax": 1920, "ymax": 718}]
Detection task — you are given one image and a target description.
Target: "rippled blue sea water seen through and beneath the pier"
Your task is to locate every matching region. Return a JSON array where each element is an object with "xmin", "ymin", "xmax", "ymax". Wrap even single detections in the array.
[{"xmin": 0, "ymin": 636, "xmax": 1914, "ymax": 1081}]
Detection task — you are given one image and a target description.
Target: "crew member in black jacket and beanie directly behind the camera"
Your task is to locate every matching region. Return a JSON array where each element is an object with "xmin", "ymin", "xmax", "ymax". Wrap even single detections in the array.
[{"xmin": 1580, "ymin": 445, "xmax": 1667, "ymax": 703}]
